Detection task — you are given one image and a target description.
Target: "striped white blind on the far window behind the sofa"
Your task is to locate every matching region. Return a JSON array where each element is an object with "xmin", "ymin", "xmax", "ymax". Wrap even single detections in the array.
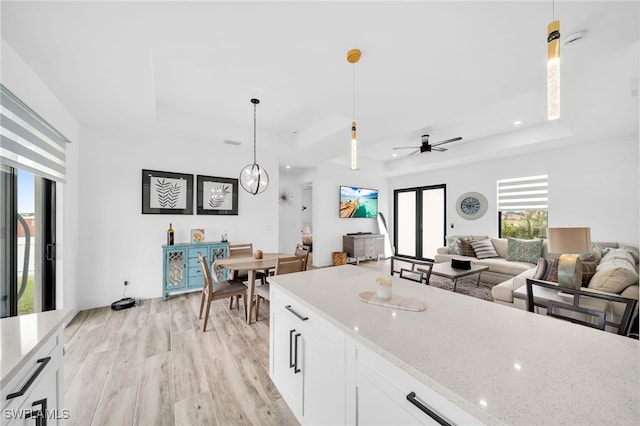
[{"xmin": 498, "ymin": 175, "xmax": 548, "ymax": 212}]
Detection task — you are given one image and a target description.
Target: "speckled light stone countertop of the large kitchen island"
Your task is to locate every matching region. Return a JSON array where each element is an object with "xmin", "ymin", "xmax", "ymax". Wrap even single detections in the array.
[{"xmin": 269, "ymin": 265, "xmax": 640, "ymax": 425}]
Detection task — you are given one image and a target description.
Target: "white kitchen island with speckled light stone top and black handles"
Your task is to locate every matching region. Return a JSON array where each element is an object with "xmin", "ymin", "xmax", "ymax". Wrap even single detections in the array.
[{"xmin": 269, "ymin": 265, "xmax": 640, "ymax": 425}]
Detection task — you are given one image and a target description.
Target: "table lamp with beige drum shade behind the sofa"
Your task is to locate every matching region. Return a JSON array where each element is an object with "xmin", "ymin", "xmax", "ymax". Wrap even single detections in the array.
[{"xmin": 547, "ymin": 228, "xmax": 591, "ymax": 290}]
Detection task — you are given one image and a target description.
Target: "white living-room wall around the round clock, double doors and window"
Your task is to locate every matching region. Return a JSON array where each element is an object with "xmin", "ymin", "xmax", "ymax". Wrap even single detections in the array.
[{"xmin": 389, "ymin": 135, "xmax": 640, "ymax": 246}]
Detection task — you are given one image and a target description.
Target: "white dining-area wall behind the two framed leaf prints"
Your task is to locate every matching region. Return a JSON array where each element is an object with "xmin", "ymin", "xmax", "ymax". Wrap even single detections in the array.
[{"xmin": 78, "ymin": 126, "xmax": 279, "ymax": 308}]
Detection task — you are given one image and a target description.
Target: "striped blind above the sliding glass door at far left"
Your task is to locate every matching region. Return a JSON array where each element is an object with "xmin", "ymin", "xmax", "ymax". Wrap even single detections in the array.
[{"xmin": 0, "ymin": 84, "xmax": 69, "ymax": 182}]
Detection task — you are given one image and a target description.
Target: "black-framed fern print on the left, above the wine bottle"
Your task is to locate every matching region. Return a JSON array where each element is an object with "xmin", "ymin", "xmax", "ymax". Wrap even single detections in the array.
[{"xmin": 142, "ymin": 169, "xmax": 193, "ymax": 214}]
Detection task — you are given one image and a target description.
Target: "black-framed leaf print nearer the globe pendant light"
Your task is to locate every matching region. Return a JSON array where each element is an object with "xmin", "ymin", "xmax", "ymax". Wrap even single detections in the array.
[{"xmin": 196, "ymin": 175, "xmax": 238, "ymax": 216}]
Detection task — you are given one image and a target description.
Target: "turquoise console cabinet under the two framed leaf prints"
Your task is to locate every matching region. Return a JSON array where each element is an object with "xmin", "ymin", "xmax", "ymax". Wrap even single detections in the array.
[{"xmin": 162, "ymin": 242, "xmax": 229, "ymax": 300}]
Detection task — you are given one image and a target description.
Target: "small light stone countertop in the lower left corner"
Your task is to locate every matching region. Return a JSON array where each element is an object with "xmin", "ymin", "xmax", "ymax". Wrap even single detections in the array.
[{"xmin": 0, "ymin": 309, "xmax": 74, "ymax": 388}]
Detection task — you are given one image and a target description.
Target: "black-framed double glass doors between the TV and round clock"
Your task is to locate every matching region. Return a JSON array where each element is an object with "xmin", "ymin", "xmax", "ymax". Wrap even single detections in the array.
[{"xmin": 394, "ymin": 185, "xmax": 446, "ymax": 260}]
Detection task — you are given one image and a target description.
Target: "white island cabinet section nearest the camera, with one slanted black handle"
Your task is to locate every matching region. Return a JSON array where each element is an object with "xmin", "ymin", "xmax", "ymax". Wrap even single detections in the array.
[{"xmin": 347, "ymin": 339, "xmax": 482, "ymax": 425}]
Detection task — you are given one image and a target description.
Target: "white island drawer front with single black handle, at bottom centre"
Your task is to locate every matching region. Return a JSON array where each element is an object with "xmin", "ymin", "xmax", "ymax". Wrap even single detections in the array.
[{"xmin": 355, "ymin": 343, "xmax": 482, "ymax": 424}]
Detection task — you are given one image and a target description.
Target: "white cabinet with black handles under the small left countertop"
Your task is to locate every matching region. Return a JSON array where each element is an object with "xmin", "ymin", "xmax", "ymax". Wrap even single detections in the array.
[{"xmin": 1, "ymin": 328, "xmax": 68, "ymax": 426}]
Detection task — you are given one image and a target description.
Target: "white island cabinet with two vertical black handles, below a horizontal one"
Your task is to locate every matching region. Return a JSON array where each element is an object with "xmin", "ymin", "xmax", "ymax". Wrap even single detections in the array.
[{"xmin": 269, "ymin": 286, "xmax": 345, "ymax": 425}]
